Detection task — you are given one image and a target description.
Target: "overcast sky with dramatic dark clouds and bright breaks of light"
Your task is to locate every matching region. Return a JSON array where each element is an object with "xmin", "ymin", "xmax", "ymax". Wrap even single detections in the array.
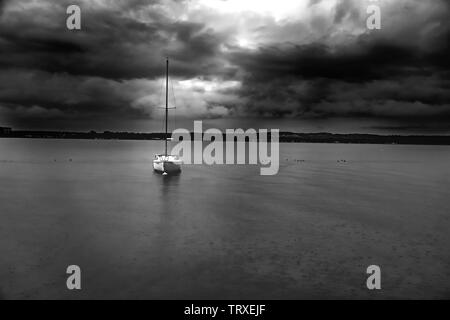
[{"xmin": 0, "ymin": 0, "xmax": 450, "ymax": 133}]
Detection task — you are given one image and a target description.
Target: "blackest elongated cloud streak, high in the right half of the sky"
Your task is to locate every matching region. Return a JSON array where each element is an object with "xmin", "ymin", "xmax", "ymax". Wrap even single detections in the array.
[{"xmin": 232, "ymin": 41, "xmax": 418, "ymax": 81}]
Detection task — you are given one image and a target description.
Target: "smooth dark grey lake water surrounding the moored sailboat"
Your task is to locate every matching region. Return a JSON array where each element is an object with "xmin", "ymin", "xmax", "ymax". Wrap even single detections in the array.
[{"xmin": 0, "ymin": 139, "xmax": 450, "ymax": 299}]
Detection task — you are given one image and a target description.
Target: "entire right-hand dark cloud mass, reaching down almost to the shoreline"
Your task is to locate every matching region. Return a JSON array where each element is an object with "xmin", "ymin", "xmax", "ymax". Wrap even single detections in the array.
[{"xmin": 225, "ymin": 1, "xmax": 450, "ymax": 121}]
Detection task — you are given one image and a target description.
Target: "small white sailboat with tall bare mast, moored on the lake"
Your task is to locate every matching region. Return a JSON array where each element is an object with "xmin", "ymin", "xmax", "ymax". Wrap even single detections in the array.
[{"xmin": 153, "ymin": 59, "xmax": 182, "ymax": 175}]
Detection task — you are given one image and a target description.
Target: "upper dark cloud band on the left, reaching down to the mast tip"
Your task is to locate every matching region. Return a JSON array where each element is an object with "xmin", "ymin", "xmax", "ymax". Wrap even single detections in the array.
[{"xmin": 0, "ymin": 1, "xmax": 229, "ymax": 79}]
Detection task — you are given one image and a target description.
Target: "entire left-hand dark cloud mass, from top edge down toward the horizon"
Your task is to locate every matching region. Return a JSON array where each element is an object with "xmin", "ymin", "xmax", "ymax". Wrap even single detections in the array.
[{"xmin": 0, "ymin": 1, "xmax": 236, "ymax": 126}]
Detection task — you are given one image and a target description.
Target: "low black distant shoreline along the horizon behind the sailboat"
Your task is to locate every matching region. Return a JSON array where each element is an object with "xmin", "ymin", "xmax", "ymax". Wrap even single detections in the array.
[{"xmin": 0, "ymin": 130, "xmax": 450, "ymax": 145}]
